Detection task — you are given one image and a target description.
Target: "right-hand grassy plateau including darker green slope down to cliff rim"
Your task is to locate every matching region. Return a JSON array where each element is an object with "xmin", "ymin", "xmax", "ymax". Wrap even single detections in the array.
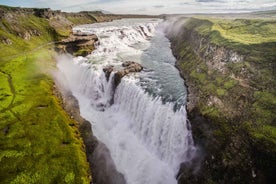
[{"xmin": 185, "ymin": 18, "xmax": 276, "ymax": 64}]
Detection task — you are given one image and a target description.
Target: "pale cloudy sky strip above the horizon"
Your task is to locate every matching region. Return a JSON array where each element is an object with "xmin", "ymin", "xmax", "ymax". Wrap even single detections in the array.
[{"xmin": 0, "ymin": 0, "xmax": 276, "ymax": 14}]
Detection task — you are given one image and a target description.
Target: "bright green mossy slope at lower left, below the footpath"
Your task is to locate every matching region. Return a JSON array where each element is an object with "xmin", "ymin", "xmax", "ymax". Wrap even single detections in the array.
[{"xmin": 0, "ymin": 49, "xmax": 89, "ymax": 183}]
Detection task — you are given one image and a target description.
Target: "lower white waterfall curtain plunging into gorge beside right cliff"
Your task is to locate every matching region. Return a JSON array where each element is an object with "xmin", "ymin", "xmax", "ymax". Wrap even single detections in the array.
[{"xmin": 113, "ymin": 80, "xmax": 191, "ymax": 171}]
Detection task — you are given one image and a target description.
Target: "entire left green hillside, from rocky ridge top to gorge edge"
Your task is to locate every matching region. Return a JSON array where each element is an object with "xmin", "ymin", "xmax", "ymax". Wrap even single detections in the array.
[{"xmin": 0, "ymin": 6, "xmax": 112, "ymax": 184}]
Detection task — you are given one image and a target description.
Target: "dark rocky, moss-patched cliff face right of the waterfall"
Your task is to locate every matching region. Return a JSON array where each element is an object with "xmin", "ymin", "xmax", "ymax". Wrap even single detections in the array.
[{"xmin": 168, "ymin": 19, "xmax": 276, "ymax": 183}]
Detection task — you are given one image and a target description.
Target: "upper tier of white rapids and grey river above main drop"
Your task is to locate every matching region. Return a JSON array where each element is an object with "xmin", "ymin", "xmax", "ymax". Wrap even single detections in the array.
[{"xmin": 74, "ymin": 19, "xmax": 187, "ymax": 109}]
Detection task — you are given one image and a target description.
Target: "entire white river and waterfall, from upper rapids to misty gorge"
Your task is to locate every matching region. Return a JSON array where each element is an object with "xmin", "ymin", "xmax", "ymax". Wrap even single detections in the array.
[{"xmin": 58, "ymin": 19, "xmax": 194, "ymax": 184}]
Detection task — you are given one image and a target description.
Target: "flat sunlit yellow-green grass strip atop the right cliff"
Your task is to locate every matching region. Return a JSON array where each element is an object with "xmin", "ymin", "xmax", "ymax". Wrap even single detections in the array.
[{"xmin": 189, "ymin": 18, "xmax": 276, "ymax": 44}]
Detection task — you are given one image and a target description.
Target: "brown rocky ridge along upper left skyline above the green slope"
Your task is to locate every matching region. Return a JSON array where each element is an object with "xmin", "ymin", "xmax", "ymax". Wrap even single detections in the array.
[{"xmin": 0, "ymin": 6, "xmax": 121, "ymax": 44}]
